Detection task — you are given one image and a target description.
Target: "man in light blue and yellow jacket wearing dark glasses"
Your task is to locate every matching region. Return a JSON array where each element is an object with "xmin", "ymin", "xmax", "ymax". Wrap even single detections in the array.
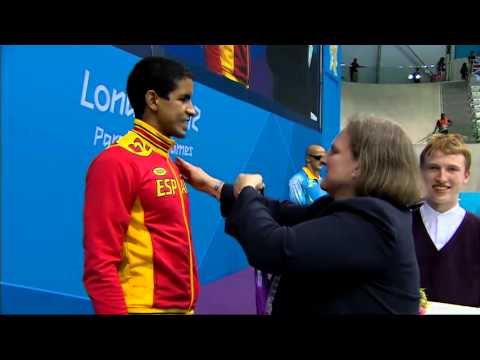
[{"xmin": 288, "ymin": 144, "xmax": 327, "ymax": 205}]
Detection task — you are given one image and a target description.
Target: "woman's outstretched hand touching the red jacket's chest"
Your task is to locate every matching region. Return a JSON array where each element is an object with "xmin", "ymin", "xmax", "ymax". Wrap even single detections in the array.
[{"xmin": 175, "ymin": 157, "xmax": 223, "ymax": 199}]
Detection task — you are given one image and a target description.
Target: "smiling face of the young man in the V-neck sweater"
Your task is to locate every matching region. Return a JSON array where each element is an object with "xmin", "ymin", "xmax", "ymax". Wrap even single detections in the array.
[{"xmin": 421, "ymin": 150, "xmax": 470, "ymax": 212}]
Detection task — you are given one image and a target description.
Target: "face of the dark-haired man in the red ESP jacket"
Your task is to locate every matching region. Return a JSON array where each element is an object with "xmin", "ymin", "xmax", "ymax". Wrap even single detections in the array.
[{"xmin": 155, "ymin": 78, "xmax": 196, "ymax": 138}]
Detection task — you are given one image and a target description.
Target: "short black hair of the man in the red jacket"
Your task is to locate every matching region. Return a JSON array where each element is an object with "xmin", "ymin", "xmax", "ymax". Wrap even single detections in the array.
[{"xmin": 127, "ymin": 56, "xmax": 192, "ymax": 118}]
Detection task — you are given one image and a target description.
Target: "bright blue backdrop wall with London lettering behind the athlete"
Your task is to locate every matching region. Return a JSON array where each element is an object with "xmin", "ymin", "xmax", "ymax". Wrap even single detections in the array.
[{"xmin": 0, "ymin": 46, "xmax": 340, "ymax": 314}]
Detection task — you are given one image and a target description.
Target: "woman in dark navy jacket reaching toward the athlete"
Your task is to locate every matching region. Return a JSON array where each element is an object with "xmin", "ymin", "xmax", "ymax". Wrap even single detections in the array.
[{"xmin": 177, "ymin": 116, "xmax": 420, "ymax": 316}]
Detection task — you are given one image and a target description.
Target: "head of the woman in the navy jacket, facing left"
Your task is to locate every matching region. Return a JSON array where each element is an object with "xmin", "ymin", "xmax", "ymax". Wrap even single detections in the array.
[{"xmin": 322, "ymin": 114, "xmax": 420, "ymax": 206}]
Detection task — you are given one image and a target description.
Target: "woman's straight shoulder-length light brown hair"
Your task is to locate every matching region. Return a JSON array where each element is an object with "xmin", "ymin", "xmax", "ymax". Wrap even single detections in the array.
[{"xmin": 346, "ymin": 114, "xmax": 420, "ymax": 206}]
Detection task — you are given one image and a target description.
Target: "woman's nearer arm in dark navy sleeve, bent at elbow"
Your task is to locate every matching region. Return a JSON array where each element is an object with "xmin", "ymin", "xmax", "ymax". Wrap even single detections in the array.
[{"xmin": 226, "ymin": 188, "xmax": 395, "ymax": 274}]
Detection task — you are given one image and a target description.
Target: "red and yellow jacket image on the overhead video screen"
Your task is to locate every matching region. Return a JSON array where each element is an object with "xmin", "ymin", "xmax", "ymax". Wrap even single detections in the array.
[{"xmin": 203, "ymin": 45, "xmax": 250, "ymax": 88}]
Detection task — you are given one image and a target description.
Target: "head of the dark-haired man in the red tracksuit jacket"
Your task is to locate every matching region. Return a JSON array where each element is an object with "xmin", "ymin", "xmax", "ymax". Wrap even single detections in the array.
[{"xmin": 127, "ymin": 56, "xmax": 196, "ymax": 137}]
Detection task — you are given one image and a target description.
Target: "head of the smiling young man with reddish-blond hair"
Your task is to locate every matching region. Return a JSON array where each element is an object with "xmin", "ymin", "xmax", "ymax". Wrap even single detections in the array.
[{"xmin": 420, "ymin": 134, "xmax": 471, "ymax": 212}]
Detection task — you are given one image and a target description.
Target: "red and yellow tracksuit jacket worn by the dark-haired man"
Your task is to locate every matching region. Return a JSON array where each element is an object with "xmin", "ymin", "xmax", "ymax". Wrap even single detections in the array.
[{"xmin": 84, "ymin": 119, "xmax": 199, "ymax": 314}]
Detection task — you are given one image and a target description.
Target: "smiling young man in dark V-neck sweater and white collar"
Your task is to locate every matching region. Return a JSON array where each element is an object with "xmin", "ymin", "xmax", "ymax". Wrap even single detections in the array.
[{"xmin": 412, "ymin": 134, "xmax": 480, "ymax": 307}]
